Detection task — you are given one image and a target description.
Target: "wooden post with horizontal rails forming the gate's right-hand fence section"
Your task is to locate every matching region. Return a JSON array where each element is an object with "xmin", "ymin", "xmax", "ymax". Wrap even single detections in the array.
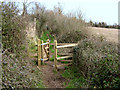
[{"xmin": 54, "ymin": 40, "xmax": 78, "ymax": 71}]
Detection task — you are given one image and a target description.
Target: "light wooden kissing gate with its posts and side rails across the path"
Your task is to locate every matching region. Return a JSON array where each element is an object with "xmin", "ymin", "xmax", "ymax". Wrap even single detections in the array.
[{"xmin": 38, "ymin": 39, "xmax": 78, "ymax": 71}]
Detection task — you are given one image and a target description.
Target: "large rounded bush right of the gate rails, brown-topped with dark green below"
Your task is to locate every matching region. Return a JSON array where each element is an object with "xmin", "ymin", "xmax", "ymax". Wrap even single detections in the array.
[{"xmin": 73, "ymin": 38, "xmax": 120, "ymax": 88}]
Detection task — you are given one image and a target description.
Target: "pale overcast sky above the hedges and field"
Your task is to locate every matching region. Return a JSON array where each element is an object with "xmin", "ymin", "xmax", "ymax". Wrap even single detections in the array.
[{"xmin": 3, "ymin": 0, "xmax": 120, "ymax": 24}]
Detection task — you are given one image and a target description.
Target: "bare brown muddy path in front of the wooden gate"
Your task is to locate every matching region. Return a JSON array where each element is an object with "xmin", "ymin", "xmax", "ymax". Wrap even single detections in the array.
[{"xmin": 39, "ymin": 61, "xmax": 69, "ymax": 88}]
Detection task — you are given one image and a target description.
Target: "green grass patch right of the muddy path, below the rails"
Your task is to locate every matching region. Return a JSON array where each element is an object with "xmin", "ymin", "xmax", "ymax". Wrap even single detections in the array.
[{"xmin": 62, "ymin": 67, "xmax": 87, "ymax": 88}]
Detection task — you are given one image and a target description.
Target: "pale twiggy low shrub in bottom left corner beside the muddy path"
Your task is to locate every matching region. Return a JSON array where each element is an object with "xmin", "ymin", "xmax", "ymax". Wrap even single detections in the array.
[{"xmin": 2, "ymin": 51, "xmax": 44, "ymax": 89}]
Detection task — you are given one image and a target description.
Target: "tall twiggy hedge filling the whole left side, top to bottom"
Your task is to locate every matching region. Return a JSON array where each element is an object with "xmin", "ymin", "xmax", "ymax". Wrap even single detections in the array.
[{"xmin": 0, "ymin": 2, "xmax": 43, "ymax": 89}]
